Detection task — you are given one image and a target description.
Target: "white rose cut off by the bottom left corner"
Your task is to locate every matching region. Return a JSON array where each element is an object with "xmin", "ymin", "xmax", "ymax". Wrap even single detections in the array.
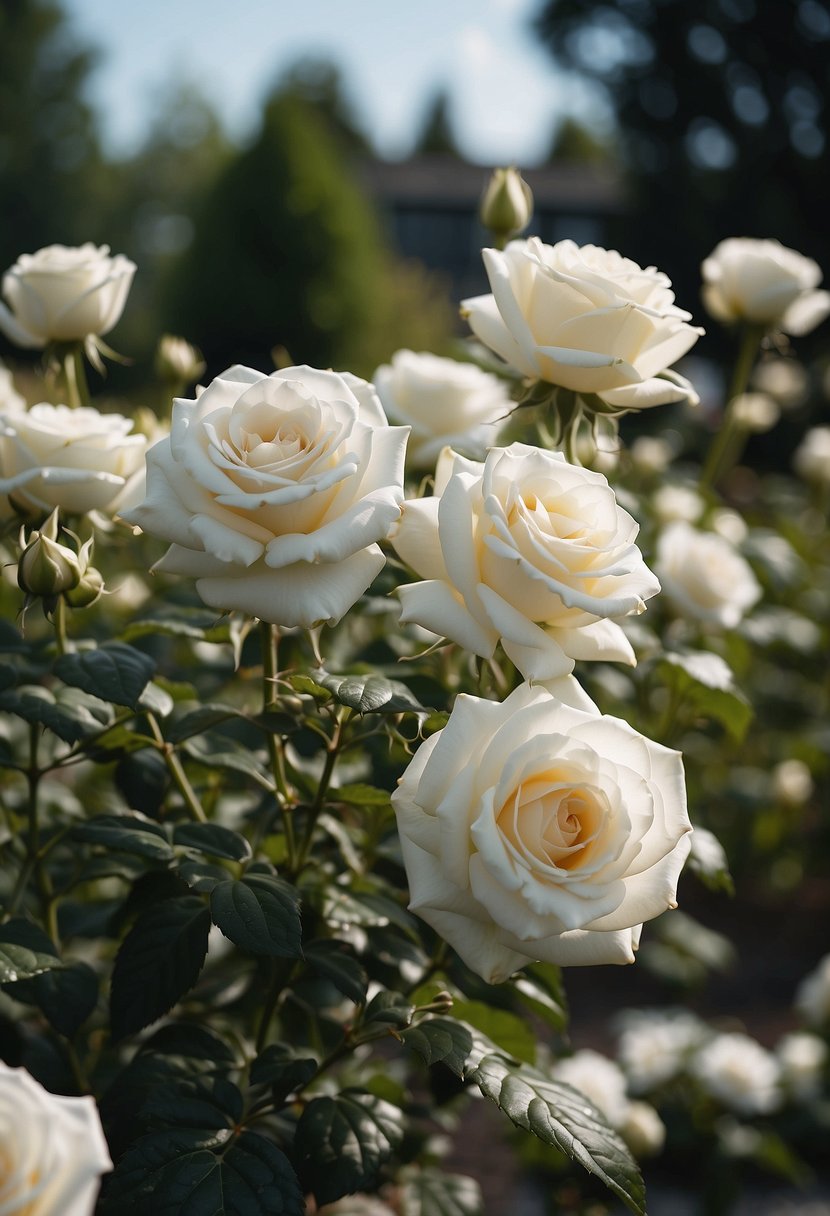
[{"xmin": 0, "ymin": 1063, "xmax": 112, "ymax": 1216}]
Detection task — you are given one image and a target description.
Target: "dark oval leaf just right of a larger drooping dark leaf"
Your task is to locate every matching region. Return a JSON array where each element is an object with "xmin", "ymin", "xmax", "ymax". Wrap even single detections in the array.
[{"xmin": 210, "ymin": 873, "xmax": 303, "ymax": 958}]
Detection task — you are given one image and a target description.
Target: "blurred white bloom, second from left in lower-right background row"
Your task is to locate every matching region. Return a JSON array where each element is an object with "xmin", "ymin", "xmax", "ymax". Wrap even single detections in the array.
[{"xmin": 617, "ymin": 1006, "xmax": 706, "ymax": 1093}]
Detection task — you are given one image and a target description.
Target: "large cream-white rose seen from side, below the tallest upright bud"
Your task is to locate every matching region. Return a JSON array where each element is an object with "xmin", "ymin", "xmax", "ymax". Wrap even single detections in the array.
[{"xmin": 462, "ymin": 237, "xmax": 704, "ymax": 410}]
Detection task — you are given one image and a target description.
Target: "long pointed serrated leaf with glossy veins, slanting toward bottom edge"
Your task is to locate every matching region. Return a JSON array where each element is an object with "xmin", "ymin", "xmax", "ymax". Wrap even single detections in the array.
[{"xmin": 468, "ymin": 1055, "xmax": 645, "ymax": 1216}]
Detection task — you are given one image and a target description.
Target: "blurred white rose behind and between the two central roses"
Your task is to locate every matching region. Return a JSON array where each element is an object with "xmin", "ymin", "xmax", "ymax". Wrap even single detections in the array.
[{"xmin": 373, "ymin": 350, "xmax": 514, "ymax": 469}]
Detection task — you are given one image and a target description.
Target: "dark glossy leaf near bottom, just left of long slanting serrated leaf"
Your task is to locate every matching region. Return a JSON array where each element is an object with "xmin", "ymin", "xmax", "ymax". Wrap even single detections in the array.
[{"xmin": 294, "ymin": 1090, "xmax": 403, "ymax": 1204}]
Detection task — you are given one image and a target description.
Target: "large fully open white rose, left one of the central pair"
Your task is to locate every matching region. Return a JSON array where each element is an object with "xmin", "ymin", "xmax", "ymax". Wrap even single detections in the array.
[{"xmin": 125, "ymin": 367, "xmax": 407, "ymax": 626}]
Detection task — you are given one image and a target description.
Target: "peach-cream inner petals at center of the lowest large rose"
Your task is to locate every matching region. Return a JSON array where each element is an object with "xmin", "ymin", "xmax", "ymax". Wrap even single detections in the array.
[{"xmin": 496, "ymin": 772, "xmax": 609, "ymax": 869}]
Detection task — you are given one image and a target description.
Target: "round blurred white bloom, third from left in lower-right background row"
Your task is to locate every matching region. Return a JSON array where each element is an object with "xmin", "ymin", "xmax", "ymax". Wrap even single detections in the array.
[{"xmin": 689, "ymin": 1032, "xmax": 781, "ymax": 1115}]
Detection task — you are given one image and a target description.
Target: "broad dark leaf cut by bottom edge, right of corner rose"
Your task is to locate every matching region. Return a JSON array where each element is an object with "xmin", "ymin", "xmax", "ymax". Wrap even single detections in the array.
[{"xmin": 103, "ymin": 1128, "xmax": 305, "ymax": 1216}]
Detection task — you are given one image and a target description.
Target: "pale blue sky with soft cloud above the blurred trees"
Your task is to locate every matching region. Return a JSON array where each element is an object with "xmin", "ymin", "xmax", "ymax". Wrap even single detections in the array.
[{"xmin": 64, "ymin": 0, "xmax": 600, "ymax": 165}]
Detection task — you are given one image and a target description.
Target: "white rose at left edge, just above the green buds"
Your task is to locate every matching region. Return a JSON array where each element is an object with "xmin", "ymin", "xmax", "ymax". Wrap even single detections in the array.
[{"xmin": 0, "ymin": 402, "xmax": 147, "ymax": 514}]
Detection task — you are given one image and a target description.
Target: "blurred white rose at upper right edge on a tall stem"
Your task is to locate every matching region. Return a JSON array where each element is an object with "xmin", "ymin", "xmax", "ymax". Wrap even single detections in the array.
[{"xmin": 700, "ymin": 237, "xmax": 830, "ymax": 334}]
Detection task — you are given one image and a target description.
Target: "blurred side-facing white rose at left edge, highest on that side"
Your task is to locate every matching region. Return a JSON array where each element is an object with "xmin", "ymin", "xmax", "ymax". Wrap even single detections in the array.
[{"xmin": 0, "ymin": 242, "xmax": 136, "ymax": 347}]
